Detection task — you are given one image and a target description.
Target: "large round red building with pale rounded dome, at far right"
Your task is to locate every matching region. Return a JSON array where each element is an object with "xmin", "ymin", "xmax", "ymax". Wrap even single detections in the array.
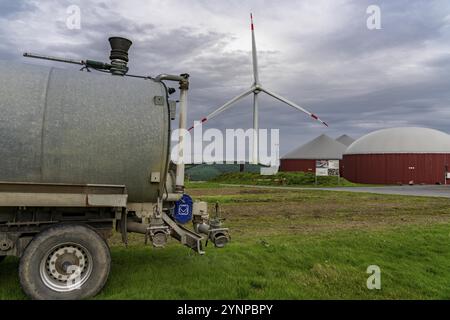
[{"xmin": 343, "ymin": 127, "xmax": 450, "ymax": 184}]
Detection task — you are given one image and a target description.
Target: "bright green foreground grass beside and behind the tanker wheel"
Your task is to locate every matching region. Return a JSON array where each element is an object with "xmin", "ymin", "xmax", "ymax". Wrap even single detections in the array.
[{"xmin": 0, "ymin": 224, "xmax": 450, "ymax": 299}]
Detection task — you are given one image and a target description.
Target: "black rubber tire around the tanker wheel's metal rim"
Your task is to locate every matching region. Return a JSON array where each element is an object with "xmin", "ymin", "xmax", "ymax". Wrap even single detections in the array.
[{"xmin": 19, "ymin": 225, "xmax": 111, "ymax": 300}]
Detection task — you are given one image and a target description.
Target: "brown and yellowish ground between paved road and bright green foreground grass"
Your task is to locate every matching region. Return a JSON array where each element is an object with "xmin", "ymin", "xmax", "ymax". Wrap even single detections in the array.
[{"xmin": 189, "ymin": 187, "xmax": 450, "ymax": 238}]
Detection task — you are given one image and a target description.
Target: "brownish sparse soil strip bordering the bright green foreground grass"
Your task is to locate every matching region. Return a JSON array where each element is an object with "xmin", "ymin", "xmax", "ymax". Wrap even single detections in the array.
[{"xmin": 222, "ymin": 202, "xmax": 450, "ymax": 235}]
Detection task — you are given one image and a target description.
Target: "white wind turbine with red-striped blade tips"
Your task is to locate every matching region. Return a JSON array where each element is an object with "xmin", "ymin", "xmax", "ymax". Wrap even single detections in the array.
[{"xmin": 189, "ymin": 13, "xmax": 328, "ymax": 164}]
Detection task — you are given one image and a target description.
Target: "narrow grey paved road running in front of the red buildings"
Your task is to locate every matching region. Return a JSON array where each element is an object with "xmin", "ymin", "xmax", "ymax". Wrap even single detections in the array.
[{"xmin": 220, "ymin": 184, "xmax": 450, "ymax": 198}]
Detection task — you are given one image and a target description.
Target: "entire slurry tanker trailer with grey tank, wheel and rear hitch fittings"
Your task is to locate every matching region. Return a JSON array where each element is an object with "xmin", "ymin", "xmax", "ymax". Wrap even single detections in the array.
[{"xmin": 0, "ymin": 37, "xmax": 229, "ymax": 299}]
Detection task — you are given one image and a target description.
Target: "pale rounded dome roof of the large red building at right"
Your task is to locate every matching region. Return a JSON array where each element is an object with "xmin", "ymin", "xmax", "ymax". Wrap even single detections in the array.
[{"xmin": 345, "ymin": 127, "xmax": 450, "ymax": 154}]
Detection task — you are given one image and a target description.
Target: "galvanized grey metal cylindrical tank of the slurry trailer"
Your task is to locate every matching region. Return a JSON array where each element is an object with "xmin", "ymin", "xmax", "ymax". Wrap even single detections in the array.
[{"xmin": 0, "ymin": 62, "xmax": 170, "ymax": 202}]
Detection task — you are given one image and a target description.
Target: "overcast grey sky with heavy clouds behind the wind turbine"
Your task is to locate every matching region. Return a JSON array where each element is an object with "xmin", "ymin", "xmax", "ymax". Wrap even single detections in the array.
[{"xmin": 0, "ymin": 0, "xmax": 450, "ymax": 154}]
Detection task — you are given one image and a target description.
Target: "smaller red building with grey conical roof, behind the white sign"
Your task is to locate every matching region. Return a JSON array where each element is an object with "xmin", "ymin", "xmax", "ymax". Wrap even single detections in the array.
[{"xmin": 280, "ymin": 134, "xmax": 347, "ymax": 173}]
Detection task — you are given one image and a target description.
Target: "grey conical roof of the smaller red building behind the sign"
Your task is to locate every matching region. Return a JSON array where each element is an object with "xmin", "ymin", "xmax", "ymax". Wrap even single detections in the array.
[{"xmin": 281, "ymin": 134, "xmax": 347, "ymax": 160}]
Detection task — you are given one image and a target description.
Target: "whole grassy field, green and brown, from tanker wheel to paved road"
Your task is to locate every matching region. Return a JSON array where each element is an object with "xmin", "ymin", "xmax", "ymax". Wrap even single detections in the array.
[{"xmin": 0, "ymin": 184, "xmax": 450, "ymax": 299}]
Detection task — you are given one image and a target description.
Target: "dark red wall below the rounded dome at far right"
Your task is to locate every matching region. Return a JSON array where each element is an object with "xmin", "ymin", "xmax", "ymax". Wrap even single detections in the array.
[{"xmin": 343, "ymin": 153, "xmax": 450, "ymax": 184}]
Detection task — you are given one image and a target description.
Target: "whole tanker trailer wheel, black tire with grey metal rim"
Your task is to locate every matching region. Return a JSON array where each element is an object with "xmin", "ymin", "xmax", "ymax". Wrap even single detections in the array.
[{"xmin": 19, "ymin": 225, "xmax": 111, "ymax": 300}]
